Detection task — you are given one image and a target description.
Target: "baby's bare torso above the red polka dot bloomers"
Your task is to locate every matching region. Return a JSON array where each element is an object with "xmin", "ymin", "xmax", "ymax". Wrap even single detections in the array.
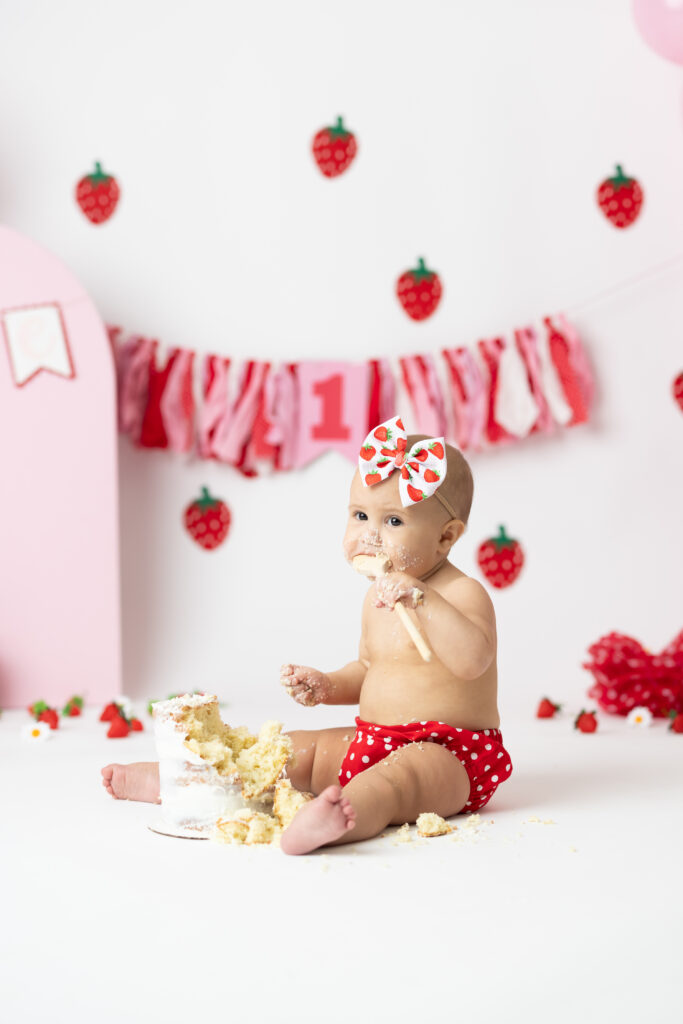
[{"xmin": 359, "ymin": 565, "xmax": 500, "ymax": 729}]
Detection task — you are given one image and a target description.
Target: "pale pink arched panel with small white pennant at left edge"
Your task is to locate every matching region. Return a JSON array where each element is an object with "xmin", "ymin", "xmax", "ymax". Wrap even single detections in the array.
[{"xmin": 0, "ymin": 227, "xmax": 121, "ymax": 708}]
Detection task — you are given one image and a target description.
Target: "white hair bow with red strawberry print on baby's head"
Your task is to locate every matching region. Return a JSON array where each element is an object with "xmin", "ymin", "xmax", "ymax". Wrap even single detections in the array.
[{"xmin": 358, "ymin": 416, "xmax": 446, "ymax": 506}]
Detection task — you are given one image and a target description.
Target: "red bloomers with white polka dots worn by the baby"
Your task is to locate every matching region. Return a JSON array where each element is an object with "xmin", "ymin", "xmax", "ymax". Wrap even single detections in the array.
[{"xmin": 339, "ymin": 718, "xmax": 512, "ymax": 814}]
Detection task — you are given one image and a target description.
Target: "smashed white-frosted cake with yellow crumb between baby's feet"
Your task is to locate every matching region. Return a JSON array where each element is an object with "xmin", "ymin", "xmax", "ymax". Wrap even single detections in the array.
[{"xmin": 153, "ymin": 693, "xmax": 298, "ymax": 842}]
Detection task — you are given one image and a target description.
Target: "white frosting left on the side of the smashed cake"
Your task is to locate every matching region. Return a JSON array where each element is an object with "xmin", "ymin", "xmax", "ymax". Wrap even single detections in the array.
[{"xmin": 154, "ymin": 695, "xmax": 247, "ymax": 833}]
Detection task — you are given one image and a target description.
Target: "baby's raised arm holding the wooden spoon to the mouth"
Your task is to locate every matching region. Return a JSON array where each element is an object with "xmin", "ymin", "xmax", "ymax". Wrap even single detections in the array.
[{"xmin": 377, "ymin": 572, "xmax": 496, "ymax": 679}]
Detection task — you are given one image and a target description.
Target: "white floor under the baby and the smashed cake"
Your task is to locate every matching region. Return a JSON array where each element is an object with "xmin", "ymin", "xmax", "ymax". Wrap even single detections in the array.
[{"xmin": 0, "ymin": 706, "xmax": 683, "ymax": 1024}]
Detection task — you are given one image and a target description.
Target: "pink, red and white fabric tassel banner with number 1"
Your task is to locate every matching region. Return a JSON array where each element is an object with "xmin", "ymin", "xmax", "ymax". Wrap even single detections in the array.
[{"xmin": 109, "ymin": 313, "xmax": 594, "ymax": 476}]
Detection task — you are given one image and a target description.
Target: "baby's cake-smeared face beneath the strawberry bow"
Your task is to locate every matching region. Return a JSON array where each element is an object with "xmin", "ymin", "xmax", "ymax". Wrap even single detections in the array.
[{"xmin": 344, "ymin": 472, "xmax": 451, "ymax": 577}]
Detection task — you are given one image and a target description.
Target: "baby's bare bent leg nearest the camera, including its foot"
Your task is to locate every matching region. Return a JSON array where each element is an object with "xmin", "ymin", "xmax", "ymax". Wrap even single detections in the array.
[{"xmin": 281, "ymin": 743, "xmax": 470, "ymax": 854}]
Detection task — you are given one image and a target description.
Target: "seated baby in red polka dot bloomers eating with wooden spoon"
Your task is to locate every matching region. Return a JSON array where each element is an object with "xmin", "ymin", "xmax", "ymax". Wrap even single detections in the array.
[{"xmin": 102, "ymin": 418, "xmax": 512, "ymax": 854}]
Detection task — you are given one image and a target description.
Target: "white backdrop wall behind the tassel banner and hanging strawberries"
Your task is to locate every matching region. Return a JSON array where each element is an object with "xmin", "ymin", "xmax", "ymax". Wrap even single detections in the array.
[{"xmin": 0, "ymin": 0, "xmax": 683, "ymax": 721}]
